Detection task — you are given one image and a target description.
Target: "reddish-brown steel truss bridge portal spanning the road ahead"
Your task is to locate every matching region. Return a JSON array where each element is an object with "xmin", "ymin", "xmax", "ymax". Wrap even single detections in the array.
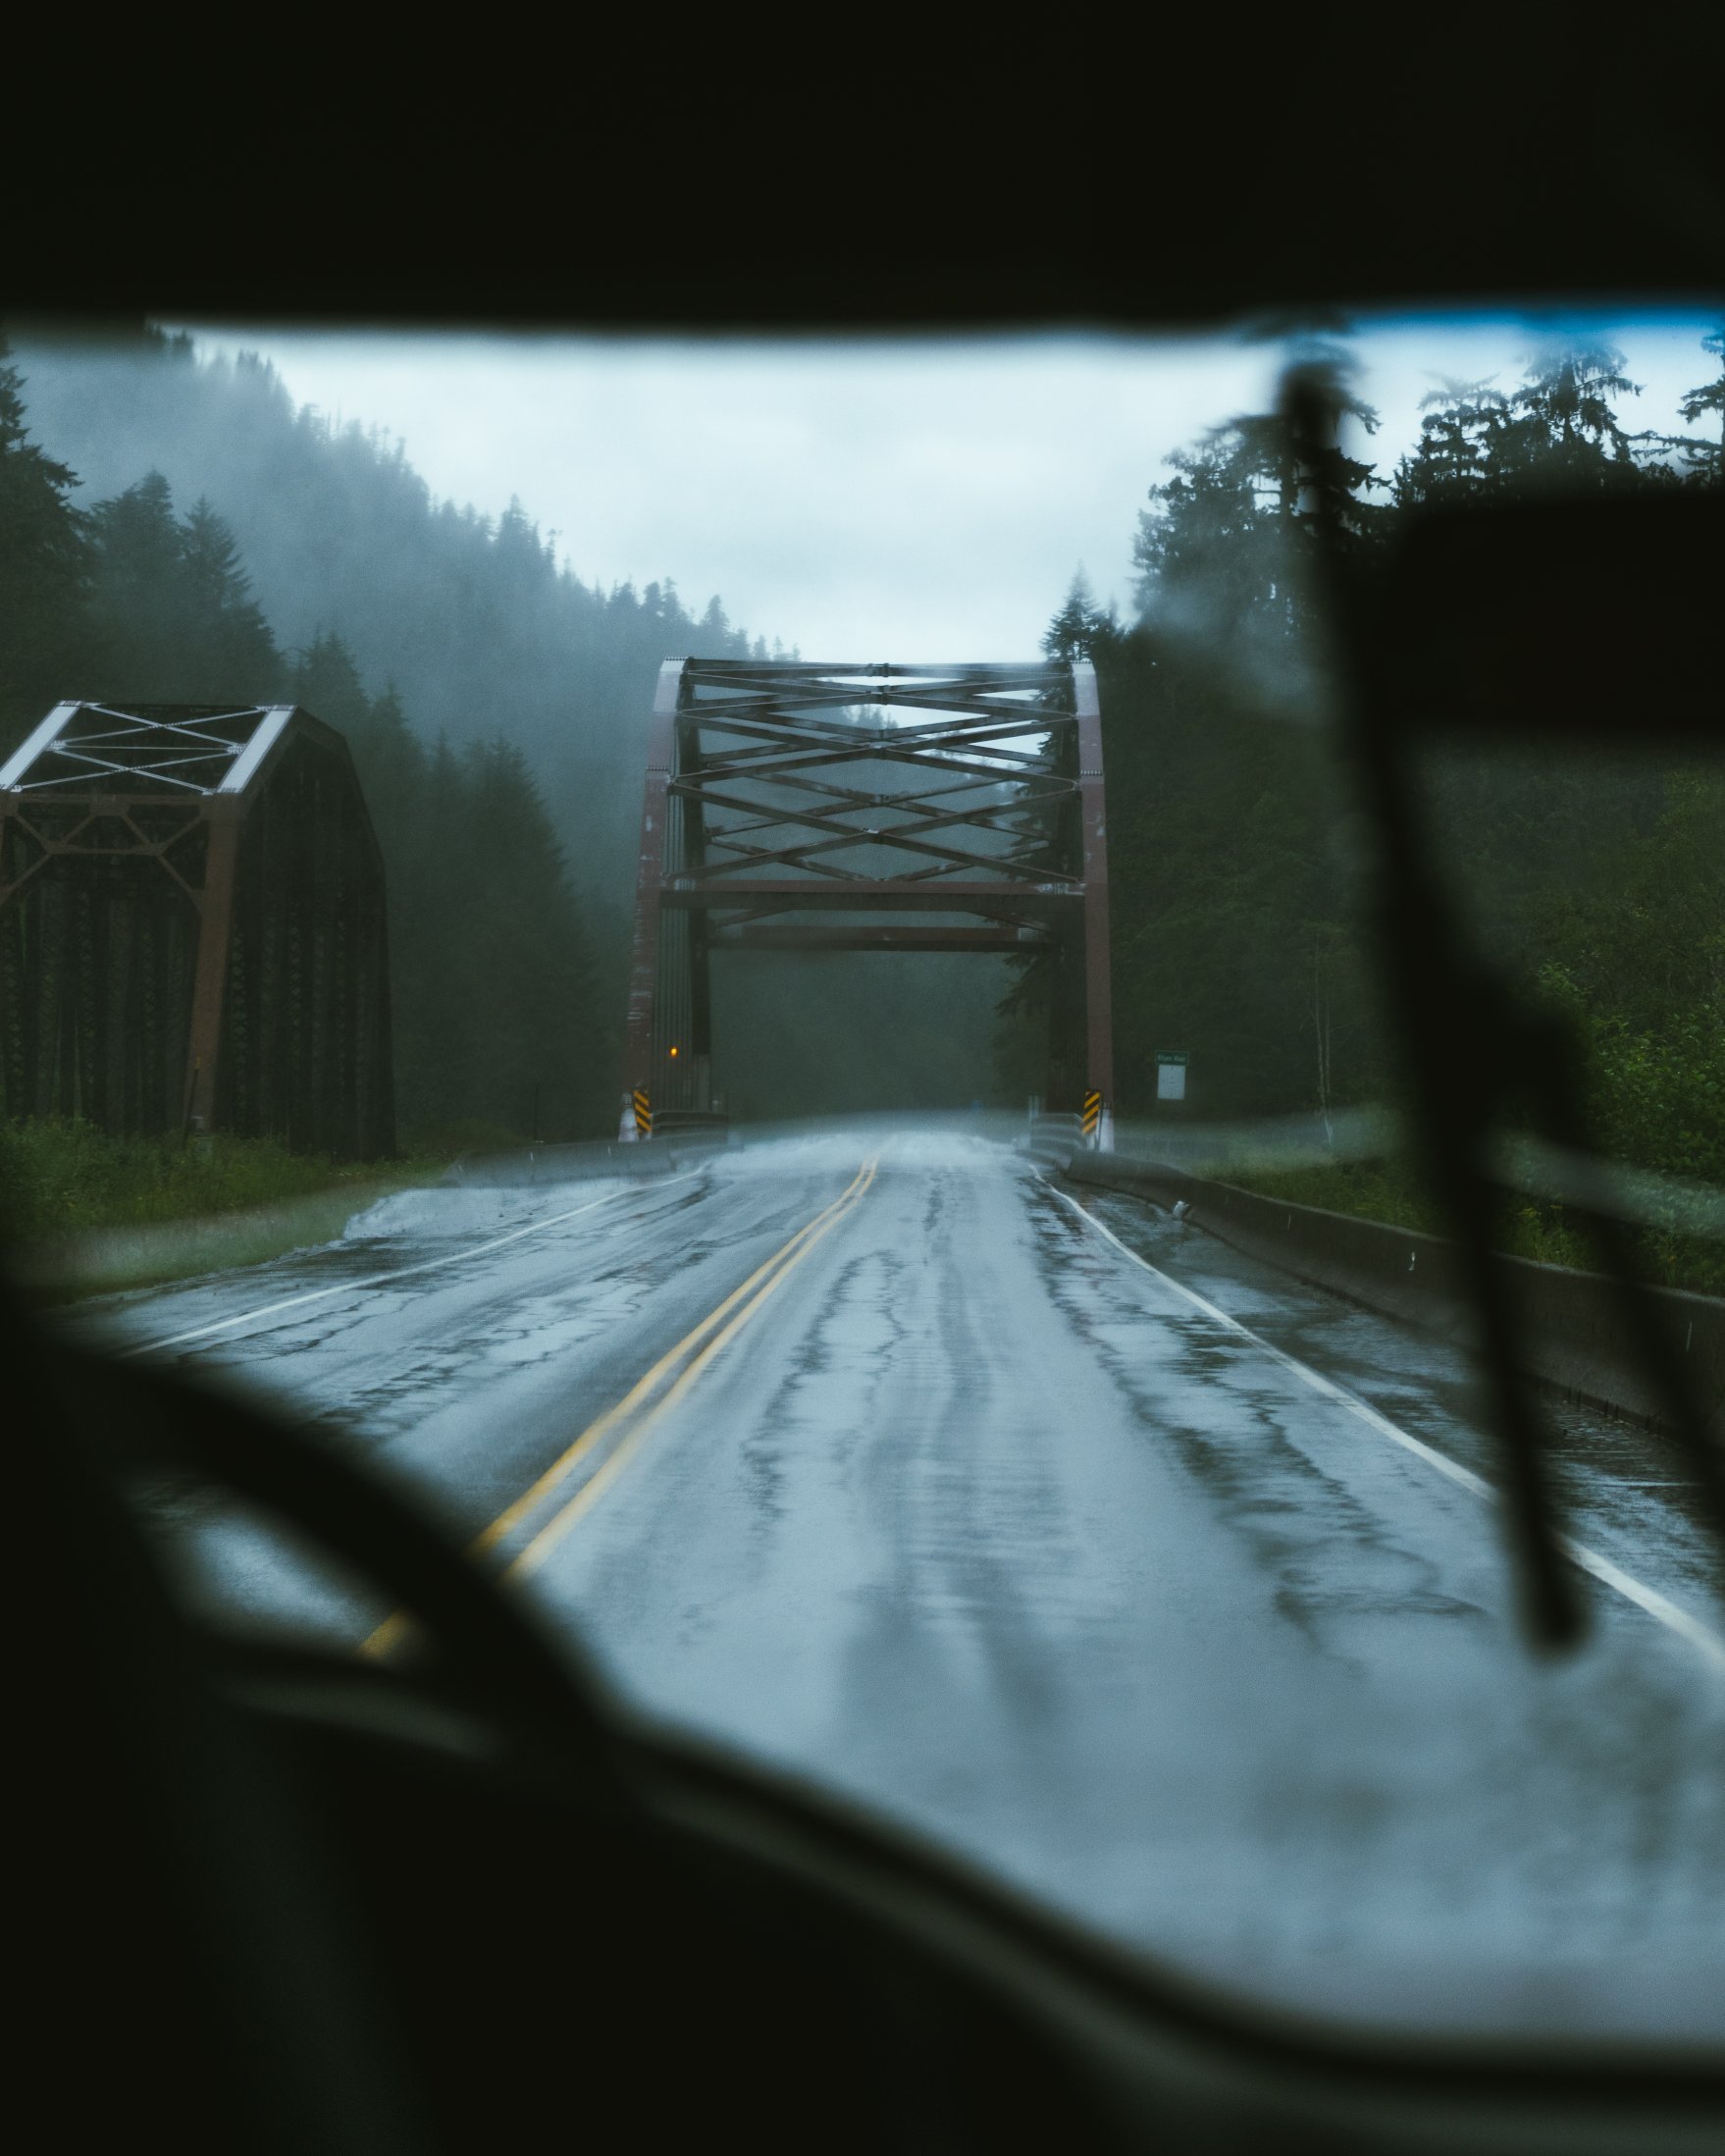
[{"xmin": 623, "ymin": 659, "xmax": 1113, "ymax": 1119}]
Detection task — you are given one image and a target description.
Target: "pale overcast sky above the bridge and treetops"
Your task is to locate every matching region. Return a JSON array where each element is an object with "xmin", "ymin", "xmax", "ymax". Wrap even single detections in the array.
[{"xmin": 174, "ymin": 319, "xmax": 1712, "ymax": 659}]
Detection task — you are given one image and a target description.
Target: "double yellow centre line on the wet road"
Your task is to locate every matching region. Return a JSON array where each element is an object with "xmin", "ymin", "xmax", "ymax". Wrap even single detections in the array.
[{"xmin": 360, "ymin": 1156, "xmax": 880, "ymax": 1656}]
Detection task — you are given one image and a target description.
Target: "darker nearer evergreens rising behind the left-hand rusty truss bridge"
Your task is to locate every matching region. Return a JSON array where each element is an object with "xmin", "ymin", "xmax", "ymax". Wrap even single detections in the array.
[{"xmin": 0, "ymin": 330, "xmax": 681, "ymax": 1147}]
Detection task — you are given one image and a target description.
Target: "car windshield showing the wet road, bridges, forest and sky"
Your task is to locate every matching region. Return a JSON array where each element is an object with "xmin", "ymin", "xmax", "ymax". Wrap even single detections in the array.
[{"xmin": 0, "ymin": 310, "xmax": 1725, "ymax": 2039}]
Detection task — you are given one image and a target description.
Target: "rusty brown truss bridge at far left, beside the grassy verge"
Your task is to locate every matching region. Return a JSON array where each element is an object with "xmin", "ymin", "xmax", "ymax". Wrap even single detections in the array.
[{"xmin": 0, "ymin": 703, "xmax": 394, "ymax": 1158}]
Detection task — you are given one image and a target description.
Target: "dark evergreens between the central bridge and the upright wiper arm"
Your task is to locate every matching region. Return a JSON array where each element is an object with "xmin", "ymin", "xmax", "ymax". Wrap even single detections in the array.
[{"xmin": 1086, "ymin": 345, "xmax": 1390, "ymax": 1128}]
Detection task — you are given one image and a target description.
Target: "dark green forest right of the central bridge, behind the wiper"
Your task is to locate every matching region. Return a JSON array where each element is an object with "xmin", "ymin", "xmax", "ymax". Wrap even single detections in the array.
[{"xmin": 1065, "ymin": 335, "xmax": 1725, "ymax": 1279}]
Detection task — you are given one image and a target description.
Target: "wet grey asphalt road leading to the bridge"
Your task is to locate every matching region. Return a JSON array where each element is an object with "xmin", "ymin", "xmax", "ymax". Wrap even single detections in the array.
[{"xmin": 74, "ymin": 1131, "xmax": 1725, "ymax": 2037}]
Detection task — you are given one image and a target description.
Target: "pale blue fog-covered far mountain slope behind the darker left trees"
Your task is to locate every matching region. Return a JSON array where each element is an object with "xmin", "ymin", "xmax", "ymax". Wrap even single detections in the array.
[{"xmin": 13, "ymin": 328, "xmax": 767, "ymax": 901}]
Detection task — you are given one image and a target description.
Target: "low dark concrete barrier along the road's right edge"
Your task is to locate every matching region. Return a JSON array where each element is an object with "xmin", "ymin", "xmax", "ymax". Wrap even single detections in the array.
[{"xmin": 1043, "ymin": 1151, "xmax": 1725, "ymax": 1443}]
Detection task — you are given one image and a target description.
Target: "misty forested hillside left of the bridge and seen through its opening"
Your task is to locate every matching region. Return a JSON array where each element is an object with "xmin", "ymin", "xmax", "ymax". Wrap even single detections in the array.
[{"xmin": 0, "ymin": 330, "xmax": 1039, "ymax": 1134}]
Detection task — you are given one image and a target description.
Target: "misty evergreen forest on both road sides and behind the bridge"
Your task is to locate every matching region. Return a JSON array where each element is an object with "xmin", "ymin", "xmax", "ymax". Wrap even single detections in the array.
[{"xmin": 0, "ymin": 314, "xmax": 1725, "ymax": 1272}]
